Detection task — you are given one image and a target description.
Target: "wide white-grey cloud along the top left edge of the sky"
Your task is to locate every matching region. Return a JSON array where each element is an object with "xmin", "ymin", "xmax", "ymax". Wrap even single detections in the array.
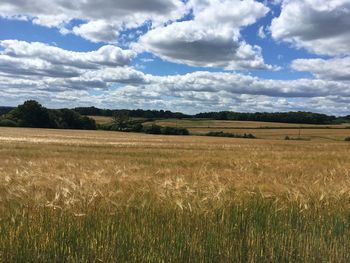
[{"xmin": 0, "ymin": 0, "xmax": 186, "ymax": 42}]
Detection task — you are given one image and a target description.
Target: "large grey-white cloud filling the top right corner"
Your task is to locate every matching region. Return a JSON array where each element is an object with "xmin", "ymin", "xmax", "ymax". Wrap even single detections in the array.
[{"xmin": 270, "ymin": 0, "xmax": 350, "ymax": 55}]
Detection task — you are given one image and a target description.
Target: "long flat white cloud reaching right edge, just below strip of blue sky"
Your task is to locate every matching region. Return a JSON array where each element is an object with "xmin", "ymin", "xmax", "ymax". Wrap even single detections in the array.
[{"xmin": 154, "ymin": 71, "xmax": 350, "ymax": 98}]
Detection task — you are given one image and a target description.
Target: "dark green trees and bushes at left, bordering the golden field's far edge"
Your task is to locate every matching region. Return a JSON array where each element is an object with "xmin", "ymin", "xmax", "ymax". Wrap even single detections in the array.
[{"xmin": 0, "ymin": 100, "xmax": 189, "ymax": 135}]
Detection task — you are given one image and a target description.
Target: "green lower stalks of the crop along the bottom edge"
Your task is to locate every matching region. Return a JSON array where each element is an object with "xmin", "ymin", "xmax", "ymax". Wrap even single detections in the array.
[{"xmin": 0, "ymin": 198, "xmax": 350, "ymax": 262}]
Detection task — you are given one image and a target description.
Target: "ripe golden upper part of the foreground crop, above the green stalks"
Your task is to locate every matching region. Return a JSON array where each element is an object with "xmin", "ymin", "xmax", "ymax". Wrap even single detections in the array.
[{"xmin": 0, "ymin": 128, "xmax": 350, "ymax": 211}]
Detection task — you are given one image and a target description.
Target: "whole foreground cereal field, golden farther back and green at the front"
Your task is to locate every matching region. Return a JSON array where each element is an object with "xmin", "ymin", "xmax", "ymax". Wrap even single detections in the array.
[{"xmin": 0, "ymin": 127, "xmax": 350, "ymax": 262}]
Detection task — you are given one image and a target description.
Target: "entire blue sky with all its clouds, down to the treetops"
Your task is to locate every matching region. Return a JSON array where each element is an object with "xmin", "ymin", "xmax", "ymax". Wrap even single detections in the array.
[{"xmin": 0, "ymin": 0, "xmax": 350, "ymax": 115}]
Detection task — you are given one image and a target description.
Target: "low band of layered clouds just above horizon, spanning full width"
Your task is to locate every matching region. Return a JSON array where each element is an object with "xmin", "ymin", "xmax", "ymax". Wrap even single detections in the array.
[{"xmin": 0, "ymin": 58, "xmax": 350, "ymax": 114}]
